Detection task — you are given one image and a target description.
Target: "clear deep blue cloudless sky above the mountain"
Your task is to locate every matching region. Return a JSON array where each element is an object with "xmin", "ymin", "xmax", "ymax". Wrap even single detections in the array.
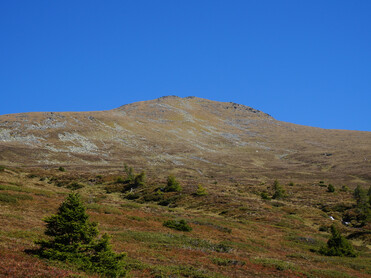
[{"xmin": 0, "ymin": 0, "xmax": 371, "ymax": 131}]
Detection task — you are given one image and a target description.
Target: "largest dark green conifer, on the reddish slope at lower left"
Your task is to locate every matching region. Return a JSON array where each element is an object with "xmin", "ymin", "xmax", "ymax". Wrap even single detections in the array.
[{"xmin": 36, "ymin": 193, "xmax": 126, "ymax": 277}]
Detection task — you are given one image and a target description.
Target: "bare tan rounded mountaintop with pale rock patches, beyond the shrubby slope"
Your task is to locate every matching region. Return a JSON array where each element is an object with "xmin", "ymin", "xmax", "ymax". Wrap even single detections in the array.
[{"xmin": 0, "ymin": 96, "xmax": 371, "ymax": 182}]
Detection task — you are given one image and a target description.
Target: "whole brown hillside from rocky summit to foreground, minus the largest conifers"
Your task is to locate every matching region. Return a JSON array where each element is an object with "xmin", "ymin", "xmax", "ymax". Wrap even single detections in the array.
[{"xmin": 0, "ymin": 96, "xmax": 371, "ymax": 278}]
